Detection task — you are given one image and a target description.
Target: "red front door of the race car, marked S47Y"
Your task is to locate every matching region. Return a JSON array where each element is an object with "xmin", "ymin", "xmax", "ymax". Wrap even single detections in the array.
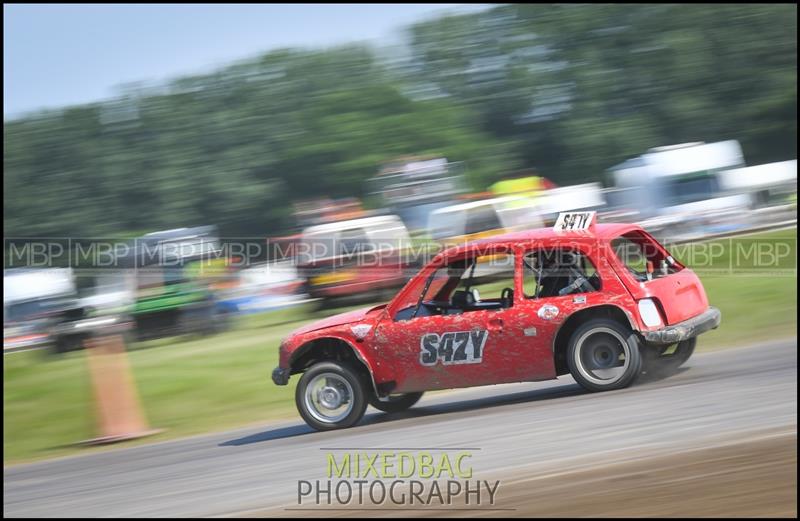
[{"xmin": 375, "ymin": 249, "xmax": 537, "ymax": 392}]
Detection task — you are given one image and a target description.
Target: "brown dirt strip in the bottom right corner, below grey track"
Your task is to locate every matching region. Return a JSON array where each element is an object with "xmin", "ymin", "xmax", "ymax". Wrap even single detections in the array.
[{"xmin": 255, "ymin": 430, "xmax": 797, "ymax": 517}]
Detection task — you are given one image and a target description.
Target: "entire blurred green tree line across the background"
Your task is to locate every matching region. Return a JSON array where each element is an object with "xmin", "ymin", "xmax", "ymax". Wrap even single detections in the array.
[{"xmin": 3, "ymin": 4, "xmax": 797, "ymax": 236}]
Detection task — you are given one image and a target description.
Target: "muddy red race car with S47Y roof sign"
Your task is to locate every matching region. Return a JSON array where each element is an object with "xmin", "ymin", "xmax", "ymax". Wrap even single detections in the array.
[{"xmin": 272, "ymin": 212, "xmax": 721, "ymax": 430}]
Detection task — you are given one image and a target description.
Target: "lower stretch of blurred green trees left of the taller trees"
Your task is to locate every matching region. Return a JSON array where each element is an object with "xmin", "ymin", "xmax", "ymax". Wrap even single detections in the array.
[{"xmin": 4, "ymin": 47, "xmax": 514, "ymax": 236}]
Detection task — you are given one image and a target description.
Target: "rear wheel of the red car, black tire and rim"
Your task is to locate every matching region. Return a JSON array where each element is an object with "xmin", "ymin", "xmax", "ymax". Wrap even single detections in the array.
[{"xmin": 567, "ymin": 318, "xmax": 642, "ymax": 392}]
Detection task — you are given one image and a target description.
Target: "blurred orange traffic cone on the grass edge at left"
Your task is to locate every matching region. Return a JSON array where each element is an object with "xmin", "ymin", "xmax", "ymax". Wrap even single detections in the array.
[{"xmin": 83, "ymin": 333, "xmax": 161, "ymax": 445}]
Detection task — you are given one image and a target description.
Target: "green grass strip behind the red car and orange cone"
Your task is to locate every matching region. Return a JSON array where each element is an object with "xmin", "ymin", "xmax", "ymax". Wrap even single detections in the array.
[{"xmin": 3, "ymin": 229, "xmax": 797, "ymax": 464}]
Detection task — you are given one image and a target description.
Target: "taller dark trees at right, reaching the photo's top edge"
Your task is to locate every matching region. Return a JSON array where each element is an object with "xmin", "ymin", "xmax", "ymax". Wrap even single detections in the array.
[{"xmin": 408, "ymin": 4, "xmax": 797, "ymax": 184}]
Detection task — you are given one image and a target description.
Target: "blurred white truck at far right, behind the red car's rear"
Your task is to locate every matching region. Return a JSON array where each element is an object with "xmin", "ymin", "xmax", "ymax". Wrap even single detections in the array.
[{"xmin": 606, "ymin": 140, "xmax": 797, "ymax": 240}]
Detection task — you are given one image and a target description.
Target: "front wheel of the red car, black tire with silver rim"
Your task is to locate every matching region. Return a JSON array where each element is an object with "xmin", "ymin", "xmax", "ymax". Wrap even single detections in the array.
[{"xmin": 295, "ymin": 362, "xmax": 367, "ymax": 431}]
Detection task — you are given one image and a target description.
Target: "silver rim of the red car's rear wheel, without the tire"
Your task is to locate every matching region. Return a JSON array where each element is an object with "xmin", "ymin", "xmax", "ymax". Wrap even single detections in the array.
[{"xmin": 573, "ymin": 327, "xmax": 631, "ymax": 385}]
